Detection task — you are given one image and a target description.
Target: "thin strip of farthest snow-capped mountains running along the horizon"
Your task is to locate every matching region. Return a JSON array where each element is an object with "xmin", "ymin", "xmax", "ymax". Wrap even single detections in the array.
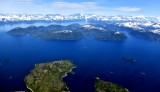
[{"xmin": 0, "ymin": 14, "xmax": 160, "ymax": 23}]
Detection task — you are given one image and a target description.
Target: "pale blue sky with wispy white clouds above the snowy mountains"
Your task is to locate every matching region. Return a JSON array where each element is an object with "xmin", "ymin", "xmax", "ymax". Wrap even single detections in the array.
[{"xmin": 0, "ymin": 0, "xmax": 160, "ymax": 16}]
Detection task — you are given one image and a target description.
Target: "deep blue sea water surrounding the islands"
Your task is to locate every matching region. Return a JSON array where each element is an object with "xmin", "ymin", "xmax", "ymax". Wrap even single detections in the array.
[{"xmin": 0, "ymin": 24, "xmax": 160, "ymax": 92}]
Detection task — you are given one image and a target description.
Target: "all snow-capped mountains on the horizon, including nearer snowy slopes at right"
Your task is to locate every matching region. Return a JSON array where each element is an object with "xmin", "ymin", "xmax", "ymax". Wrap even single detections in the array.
[{"xmin": 0, "ymin": 14, "xmax": 160, "ymax": 37}]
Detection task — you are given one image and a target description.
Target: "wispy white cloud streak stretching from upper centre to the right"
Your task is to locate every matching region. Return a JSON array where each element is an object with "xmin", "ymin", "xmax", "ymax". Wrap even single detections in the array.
[{"xmin": 53, "ymin": 2, "xmax": 141, "ymax": 12}]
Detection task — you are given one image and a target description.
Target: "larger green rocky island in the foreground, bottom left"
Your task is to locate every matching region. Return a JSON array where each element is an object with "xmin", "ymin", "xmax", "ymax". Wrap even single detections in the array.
[{"xmin": 25, "ymin": 60, "xmax": 76, "ymax": 92}]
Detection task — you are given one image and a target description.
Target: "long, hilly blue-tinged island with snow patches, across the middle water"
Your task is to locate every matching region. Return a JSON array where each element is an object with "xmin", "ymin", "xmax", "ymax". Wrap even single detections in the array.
[{"xmin": 8, "ymin": 24, "xmax": 127, "ymax": 41}]
